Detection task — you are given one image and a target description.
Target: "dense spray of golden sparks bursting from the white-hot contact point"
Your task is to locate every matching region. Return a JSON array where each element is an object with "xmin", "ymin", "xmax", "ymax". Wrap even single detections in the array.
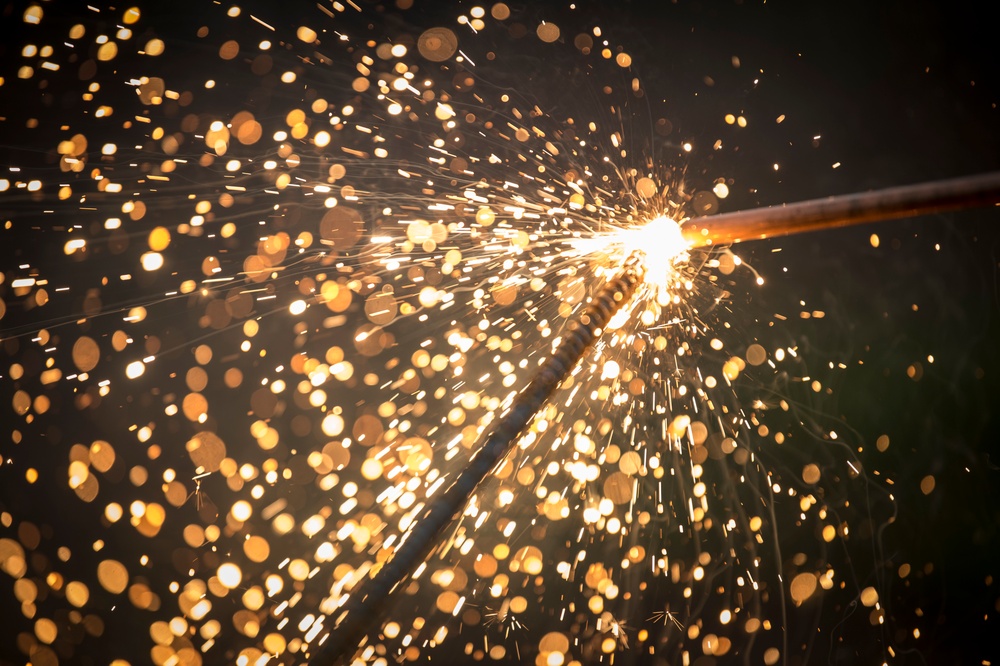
[{"xmin": 0, "ymin": 2, "xmax": 882, "ymax": 666}]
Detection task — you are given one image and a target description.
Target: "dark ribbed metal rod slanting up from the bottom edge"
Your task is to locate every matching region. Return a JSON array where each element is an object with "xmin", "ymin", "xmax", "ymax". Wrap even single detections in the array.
[{"xmin": 309, "ymin": 257, "xmax": 643, "ymax": 666}]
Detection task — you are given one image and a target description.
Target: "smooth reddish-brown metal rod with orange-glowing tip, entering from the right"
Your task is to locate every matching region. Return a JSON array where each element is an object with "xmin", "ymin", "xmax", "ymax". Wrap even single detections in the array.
[{"xmin": 682, "ymin": 172, "xmax": 1000, "ymax": 247}]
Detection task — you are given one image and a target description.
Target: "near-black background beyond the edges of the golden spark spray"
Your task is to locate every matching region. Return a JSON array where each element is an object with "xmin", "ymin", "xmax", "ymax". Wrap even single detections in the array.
[{"xmin": 0, "ymin": 0, "xmax": 1000, "ymax": 664}]
